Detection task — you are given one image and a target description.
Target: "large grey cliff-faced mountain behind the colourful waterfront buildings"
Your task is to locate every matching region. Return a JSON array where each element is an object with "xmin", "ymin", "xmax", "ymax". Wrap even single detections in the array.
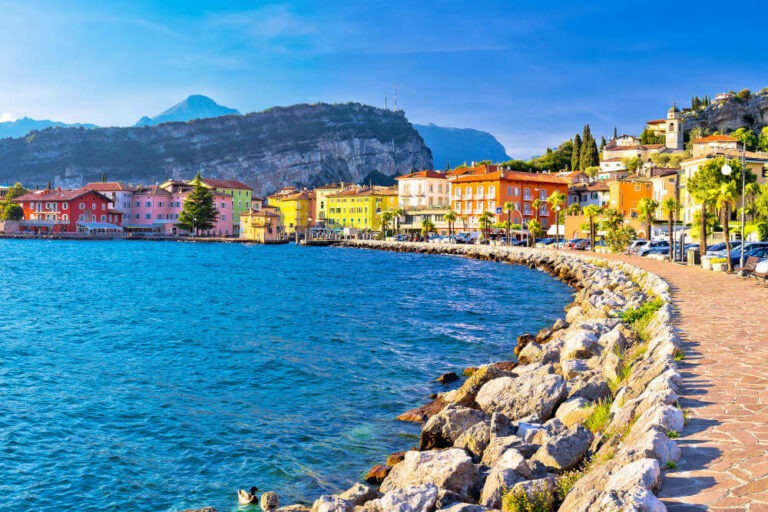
[{"xmin": 0, "ymin": 103, "xmax": 432, "ymax": 195}]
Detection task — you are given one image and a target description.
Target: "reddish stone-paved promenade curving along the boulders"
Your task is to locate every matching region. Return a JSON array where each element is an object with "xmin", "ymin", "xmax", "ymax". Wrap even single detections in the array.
[{"xmin": 584, "ymin": 254, "xmax": 768, "ymax": 512}]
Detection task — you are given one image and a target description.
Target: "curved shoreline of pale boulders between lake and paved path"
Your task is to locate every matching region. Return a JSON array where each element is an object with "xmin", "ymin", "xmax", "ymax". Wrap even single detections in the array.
[{"xmin": 194, "ymin": 241, "xmax": 685, "ymax": 512}]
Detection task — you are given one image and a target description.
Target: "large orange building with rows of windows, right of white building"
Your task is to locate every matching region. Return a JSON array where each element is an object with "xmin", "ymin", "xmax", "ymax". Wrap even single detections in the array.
[{"xmin": 451, "ymin": 166, "xmax": 568, "ymax": 231}]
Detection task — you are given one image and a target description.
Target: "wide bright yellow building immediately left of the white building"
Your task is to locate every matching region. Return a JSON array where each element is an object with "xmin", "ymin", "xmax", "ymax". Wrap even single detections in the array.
[{"xmin": 326, "ymin": 186, "xmax": 397, "ymax": 231}]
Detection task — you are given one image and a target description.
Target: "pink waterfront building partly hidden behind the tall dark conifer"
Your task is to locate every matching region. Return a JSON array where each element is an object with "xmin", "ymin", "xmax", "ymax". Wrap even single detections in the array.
[{"xmin": 124, "ymin": 180, "xmax": 233, "ymax": 236}]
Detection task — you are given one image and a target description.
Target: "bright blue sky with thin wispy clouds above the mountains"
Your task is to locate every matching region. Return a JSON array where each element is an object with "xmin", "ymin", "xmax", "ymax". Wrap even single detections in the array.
[{"xmin": 0, "ymin": 0, "xmax": 768, "ymax": 157}]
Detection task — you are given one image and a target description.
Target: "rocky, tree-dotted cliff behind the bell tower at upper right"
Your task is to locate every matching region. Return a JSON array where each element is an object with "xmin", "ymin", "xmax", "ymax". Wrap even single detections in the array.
[{"xmin": 685, "ymin": 89, "xmax": 768, "ymax": 132}]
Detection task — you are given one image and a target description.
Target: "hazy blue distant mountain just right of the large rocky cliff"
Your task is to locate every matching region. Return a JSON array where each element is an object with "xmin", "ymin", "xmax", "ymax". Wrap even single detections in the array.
[{"xmin": 413, "ymin": 123, "xmax": 510, "ymax": 169}]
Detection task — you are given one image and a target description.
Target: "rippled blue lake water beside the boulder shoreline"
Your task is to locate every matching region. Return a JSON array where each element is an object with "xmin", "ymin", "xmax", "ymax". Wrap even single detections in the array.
[{"xmin": 0, "ymin": 240, "xmax": 572, "ymax": 512}]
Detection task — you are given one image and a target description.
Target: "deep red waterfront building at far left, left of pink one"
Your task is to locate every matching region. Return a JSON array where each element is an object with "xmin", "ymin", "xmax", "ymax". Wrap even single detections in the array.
[{"xmin": 16, "ymin": 188, "xmax": 122, "ymax": 233}]
